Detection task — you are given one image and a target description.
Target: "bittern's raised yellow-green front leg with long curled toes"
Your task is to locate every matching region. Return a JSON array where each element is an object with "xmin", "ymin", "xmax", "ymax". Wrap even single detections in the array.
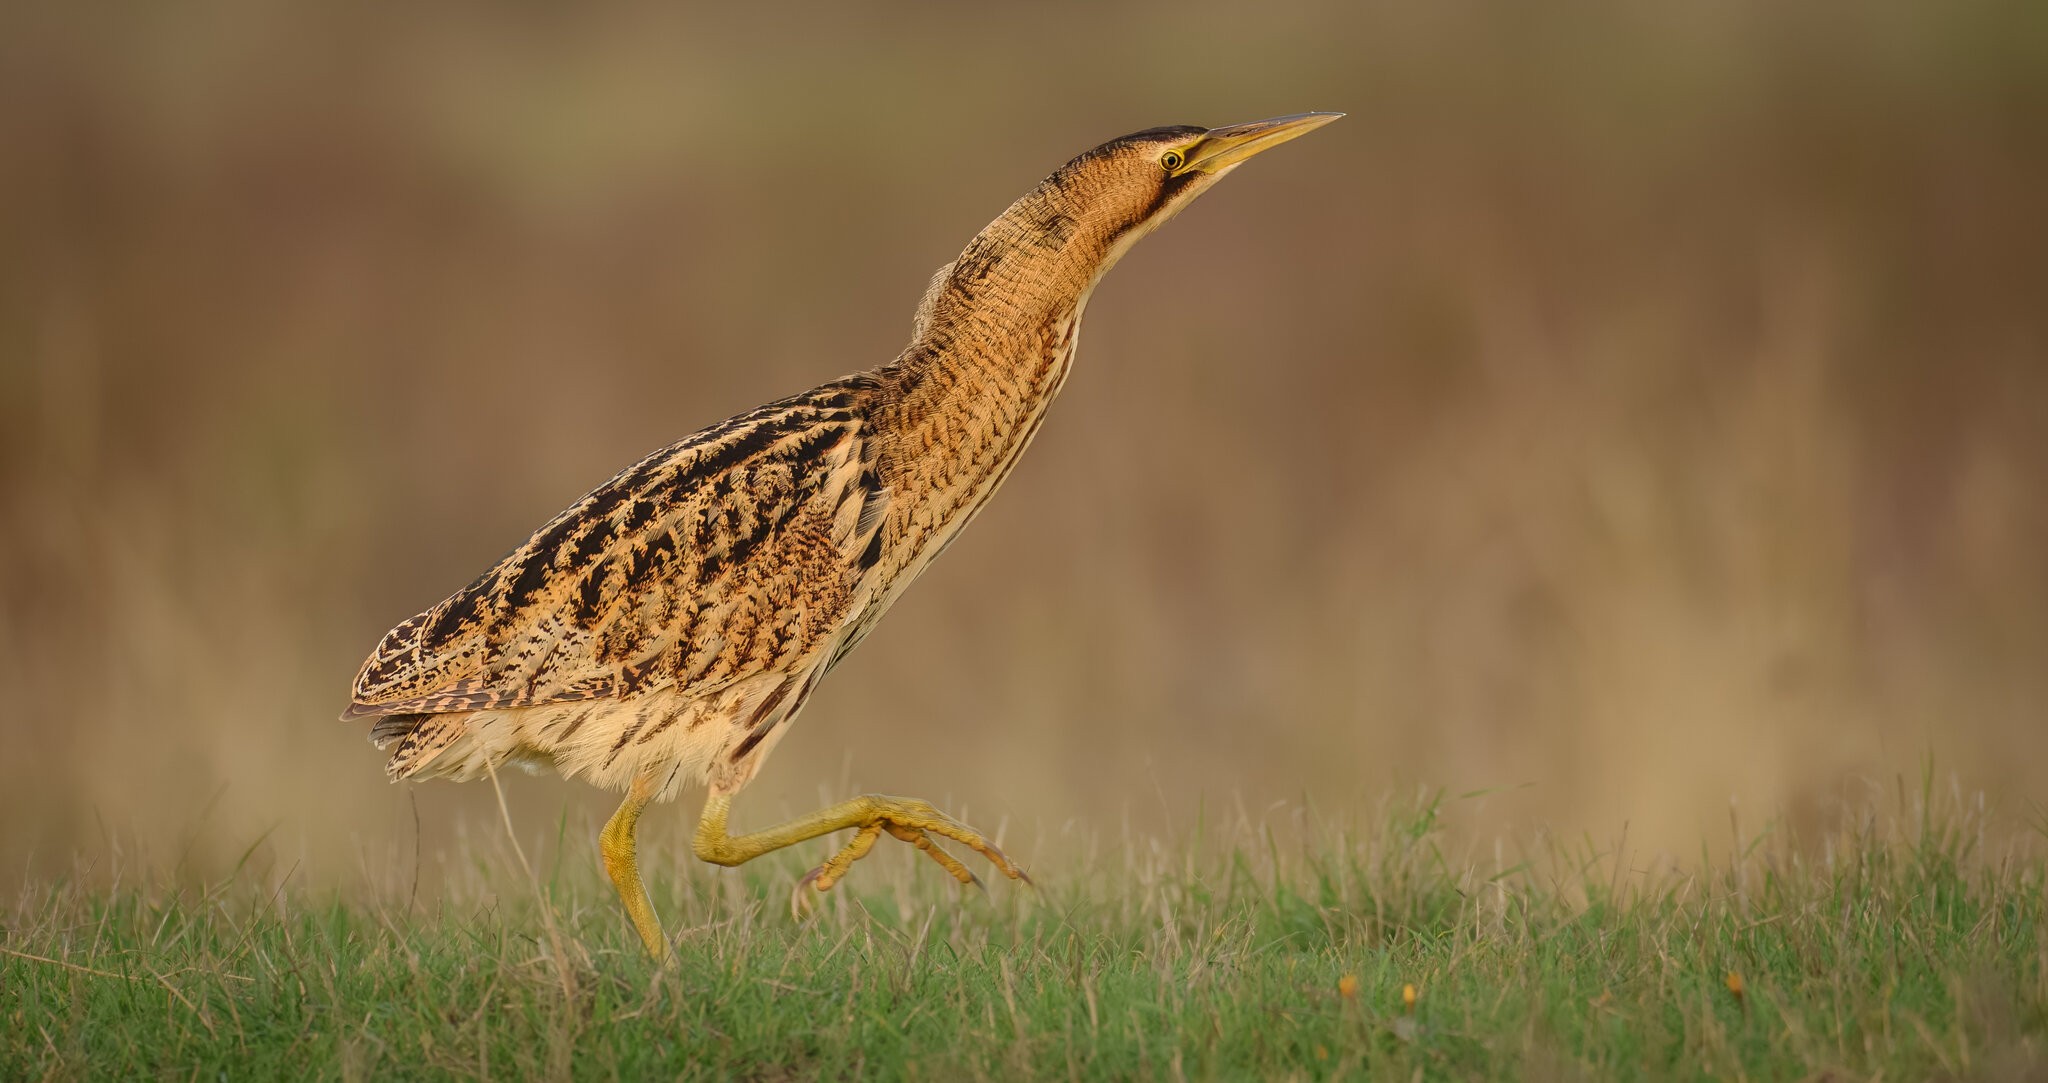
[{"xmin": 696, "ymin": 792, "xmax": 1030, "ymax": 908}]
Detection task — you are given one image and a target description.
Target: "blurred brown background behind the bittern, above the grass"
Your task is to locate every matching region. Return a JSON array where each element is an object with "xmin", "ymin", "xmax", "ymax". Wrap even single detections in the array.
[{"xmin": 0, "ymin": 0, "xmax": 2048, "ymax": 882}]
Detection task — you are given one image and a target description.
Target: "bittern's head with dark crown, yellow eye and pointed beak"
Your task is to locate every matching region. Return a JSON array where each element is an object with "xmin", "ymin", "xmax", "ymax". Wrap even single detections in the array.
[{"xmin": 1049, "ymin": 113, "xmax": 1343, "ymax": 262}]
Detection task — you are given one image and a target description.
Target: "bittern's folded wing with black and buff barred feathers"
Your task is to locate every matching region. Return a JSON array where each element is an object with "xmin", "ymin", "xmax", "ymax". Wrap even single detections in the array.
[{"xmin": 344, "ymin": 377, "xmax": 889, "ymax": 719}]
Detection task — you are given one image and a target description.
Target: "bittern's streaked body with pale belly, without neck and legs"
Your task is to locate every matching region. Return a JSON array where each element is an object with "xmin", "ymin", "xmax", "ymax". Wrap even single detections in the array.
[{"xmin": 348, "ymin": 377, "xmax": 889, "ymax": 790}]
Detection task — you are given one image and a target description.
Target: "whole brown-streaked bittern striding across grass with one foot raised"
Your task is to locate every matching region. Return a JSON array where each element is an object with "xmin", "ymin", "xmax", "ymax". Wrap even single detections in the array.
[{"xmin": 344, "ymin": 113, "xmax": 1339, "ymax": 958}]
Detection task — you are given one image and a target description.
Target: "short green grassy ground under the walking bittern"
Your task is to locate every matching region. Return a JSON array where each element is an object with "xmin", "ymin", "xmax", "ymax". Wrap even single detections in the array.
[{"xmin": 0, "ymin": 788, "xmax": 2048, "ymax": 1079}]
